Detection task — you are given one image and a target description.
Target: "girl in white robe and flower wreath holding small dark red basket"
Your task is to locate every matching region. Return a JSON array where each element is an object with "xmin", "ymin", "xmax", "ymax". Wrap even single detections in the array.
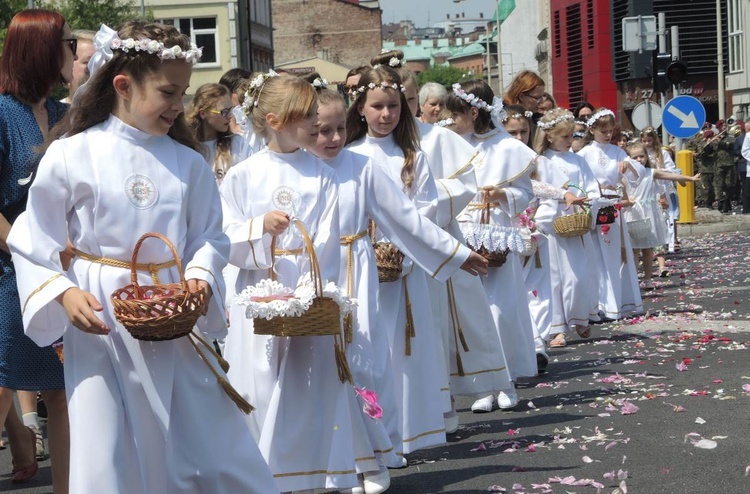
[{"xmin": 578, "ymin": 108, "xmax": 643, "ymax": 319}]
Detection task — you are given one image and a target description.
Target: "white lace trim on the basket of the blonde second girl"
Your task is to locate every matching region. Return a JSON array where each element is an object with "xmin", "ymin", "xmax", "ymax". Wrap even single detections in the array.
[{"xmin": 234, "ymin": 277, "xmax": 357, "ymax": 320}]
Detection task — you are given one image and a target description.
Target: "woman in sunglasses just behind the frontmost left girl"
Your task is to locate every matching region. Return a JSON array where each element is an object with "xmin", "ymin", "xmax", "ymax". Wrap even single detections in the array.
[{"xmin": 185, "ymin": 84, "xmax": 247, "ymax": 183}]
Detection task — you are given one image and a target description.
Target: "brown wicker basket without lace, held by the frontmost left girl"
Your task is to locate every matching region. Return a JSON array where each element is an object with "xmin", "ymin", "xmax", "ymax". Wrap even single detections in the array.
[{"xmin": 110, "ymin": 232, "xmax": 206, "ymax": 341}]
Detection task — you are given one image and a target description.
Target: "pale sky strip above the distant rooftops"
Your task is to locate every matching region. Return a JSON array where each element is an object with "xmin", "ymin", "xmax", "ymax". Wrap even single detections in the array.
[{"xmin": 380, "ymin": 0, "xmax": 488, "ymax": 27}]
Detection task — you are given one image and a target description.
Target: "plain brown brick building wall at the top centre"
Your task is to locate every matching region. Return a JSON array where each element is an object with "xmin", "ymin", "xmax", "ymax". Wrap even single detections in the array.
[{"xmin": 271, "ymin": 0, "xmax": 382, "ymax": 67}]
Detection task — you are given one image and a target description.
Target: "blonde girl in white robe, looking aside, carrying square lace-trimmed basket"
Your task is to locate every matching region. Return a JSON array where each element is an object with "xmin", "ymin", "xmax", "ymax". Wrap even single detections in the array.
[{"xmin": 221, "ymin": 74, "xmax": 378, "ymax": 493}]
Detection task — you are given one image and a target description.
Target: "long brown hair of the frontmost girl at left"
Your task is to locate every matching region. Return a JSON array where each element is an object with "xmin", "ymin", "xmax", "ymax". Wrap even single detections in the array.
[{"xmin": 42, "ymin": 21, "xmax": 201, "ymax": 152}]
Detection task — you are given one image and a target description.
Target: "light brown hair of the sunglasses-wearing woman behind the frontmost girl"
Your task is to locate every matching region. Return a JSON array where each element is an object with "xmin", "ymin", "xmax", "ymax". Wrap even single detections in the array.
[{"xmin": 185, "ymin": 84, "xmax": 233, "ymax": 179}]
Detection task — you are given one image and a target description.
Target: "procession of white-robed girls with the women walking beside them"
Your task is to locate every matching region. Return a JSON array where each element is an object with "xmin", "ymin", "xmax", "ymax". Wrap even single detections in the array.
[{"xmin": 0, "ymin": 10, "xmax": 740, "ymax": 494}]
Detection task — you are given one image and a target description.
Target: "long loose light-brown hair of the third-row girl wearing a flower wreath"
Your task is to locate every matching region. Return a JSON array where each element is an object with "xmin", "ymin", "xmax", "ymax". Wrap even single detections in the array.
[{"xmin": 346, "ymin": 65, "xmax": 419, "ymax": 191}]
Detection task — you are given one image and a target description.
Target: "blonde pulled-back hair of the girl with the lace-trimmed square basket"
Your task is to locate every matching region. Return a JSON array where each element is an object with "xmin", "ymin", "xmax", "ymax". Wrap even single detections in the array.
[{"xmin": 249, "ymin": 74, "xmax": 318, "ymax": 139}]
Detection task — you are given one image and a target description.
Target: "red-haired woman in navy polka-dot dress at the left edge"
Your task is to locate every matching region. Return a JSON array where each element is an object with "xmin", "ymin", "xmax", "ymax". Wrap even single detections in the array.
[{"xmin": 0, "ymin": 10, "xmax": 76, "ymax": 494}]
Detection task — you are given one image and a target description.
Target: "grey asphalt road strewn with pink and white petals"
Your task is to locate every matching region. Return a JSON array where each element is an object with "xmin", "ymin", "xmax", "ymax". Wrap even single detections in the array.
[{"xmin": 5, "ymin": 233, "xmax": 750, "ymax": 494}]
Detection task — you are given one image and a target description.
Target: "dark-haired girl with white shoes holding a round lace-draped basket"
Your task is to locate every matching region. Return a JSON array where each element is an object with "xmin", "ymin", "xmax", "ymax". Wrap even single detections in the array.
[{"xmin": 446, "ymin": 80, "xmax": 537, "ymax": 412}]
